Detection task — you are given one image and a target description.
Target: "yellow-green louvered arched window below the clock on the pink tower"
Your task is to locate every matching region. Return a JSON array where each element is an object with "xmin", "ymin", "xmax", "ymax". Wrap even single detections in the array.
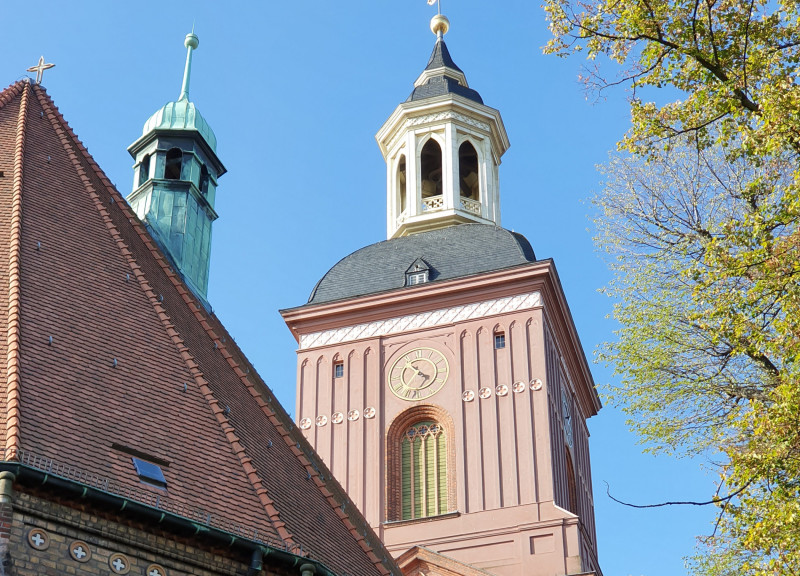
[{"xmin": 401, "ymin": 421, "xmax": 448, "ymax": 520}]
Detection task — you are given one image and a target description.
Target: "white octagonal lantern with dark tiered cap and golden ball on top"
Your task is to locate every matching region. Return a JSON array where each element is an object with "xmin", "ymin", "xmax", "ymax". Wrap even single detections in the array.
[{"xmin": 376, "ymin": 14, "xmax": 509, "ymax": 238}]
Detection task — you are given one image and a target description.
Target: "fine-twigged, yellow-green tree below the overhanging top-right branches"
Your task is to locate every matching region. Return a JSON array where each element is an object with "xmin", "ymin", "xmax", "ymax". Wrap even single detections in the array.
[{"xmin": 595, "ymin": 136, "xmax": 800, "ymax": 574}]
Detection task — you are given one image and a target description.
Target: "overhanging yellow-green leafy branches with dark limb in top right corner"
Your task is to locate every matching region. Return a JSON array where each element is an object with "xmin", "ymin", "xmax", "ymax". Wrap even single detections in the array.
[{"xmin": 545, "ymin": 0, "xmax": 800, "ymax": 156}]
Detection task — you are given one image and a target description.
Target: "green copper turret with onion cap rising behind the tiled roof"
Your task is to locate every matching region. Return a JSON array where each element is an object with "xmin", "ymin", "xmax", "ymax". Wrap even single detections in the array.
[{"xmin": 128, "ymin": 32, "xmax": 225, "ymax": 301}]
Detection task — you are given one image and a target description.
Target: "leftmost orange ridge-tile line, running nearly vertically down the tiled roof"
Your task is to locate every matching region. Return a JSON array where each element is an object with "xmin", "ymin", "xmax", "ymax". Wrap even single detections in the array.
[{"xmin": 2, "ymin": 82, "xmax": 30, "ymax": 459}]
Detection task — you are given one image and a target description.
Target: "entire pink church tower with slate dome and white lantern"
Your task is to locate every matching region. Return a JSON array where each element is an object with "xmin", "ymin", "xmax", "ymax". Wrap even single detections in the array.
[{"xmin": 282, "ymin": 15, "xmax": 601, "ymax": 576}]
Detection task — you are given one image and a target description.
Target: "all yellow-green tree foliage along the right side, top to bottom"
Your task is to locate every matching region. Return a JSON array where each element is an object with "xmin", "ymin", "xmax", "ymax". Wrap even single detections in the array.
[{"xmin": 545, "ymin": 0, "xmax": 800, "ymax": 576}]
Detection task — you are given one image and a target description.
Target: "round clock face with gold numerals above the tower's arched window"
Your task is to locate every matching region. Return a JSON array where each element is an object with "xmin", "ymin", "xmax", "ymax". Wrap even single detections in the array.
[{"xmin": 386, "ymin": 348, "xmax": 450, "ymax": 402}]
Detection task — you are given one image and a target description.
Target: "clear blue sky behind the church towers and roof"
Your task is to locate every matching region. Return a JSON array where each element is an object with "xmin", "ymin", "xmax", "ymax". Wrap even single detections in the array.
[{"xmin": 0, "ymin": 0, "xmax": 714, "ymax": 576}]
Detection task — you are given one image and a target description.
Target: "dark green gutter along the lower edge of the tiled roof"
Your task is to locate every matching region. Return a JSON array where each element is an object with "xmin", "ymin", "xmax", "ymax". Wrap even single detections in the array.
[{"xmin": 0, "ymin": 461, "xmax": 338, "ymax": 576}]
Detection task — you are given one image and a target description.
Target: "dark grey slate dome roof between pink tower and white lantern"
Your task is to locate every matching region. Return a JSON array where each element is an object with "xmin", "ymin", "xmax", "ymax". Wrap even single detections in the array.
[{"xmin": 308, "ymin": 224, "xmax": 536, "ymax": 304}]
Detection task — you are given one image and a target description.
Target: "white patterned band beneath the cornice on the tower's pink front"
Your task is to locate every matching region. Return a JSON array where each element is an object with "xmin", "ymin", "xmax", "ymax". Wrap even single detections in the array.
[{"xmin": 300, "ymin": 292, "xmax": 542, "ymax": 350}]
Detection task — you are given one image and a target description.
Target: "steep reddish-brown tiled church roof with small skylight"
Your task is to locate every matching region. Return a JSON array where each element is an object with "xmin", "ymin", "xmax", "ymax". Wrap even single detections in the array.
[{"xmin": 0, "ymin": 81, "xmax": 397, "ymax": 576}]
